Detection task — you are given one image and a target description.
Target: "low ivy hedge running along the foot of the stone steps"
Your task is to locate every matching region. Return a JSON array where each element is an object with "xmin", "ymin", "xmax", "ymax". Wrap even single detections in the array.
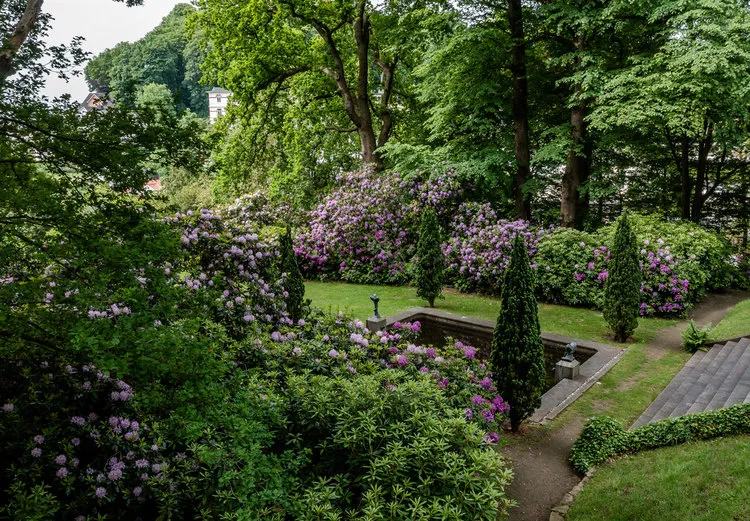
[{"xmin": 570, "ymin": 403, "xmax": 750, "ymax": 472}]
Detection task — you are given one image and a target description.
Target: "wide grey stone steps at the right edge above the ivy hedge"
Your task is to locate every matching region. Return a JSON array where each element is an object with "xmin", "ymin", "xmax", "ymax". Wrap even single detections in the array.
[{"xmin": 631, "ymin": 336, "xmax": 750, "ymax": 429}]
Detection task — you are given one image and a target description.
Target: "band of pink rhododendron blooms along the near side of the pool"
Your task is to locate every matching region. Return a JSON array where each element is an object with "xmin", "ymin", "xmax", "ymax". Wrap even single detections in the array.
[{"xmin": 250, "ymin": 315, "xmax": 508, "ymax": 441}]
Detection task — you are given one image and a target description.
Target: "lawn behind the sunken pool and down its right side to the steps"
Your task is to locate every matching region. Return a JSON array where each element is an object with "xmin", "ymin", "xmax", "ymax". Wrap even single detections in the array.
[{"xmin": 305, "ymin": 282, "xmax": 690, "ymax": 422}]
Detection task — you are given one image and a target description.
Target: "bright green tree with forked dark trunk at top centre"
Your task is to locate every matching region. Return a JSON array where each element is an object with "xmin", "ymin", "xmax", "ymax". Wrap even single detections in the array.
[{"xmin": 196, "ymin": 0, "xmax": 450, "ymax": 169}]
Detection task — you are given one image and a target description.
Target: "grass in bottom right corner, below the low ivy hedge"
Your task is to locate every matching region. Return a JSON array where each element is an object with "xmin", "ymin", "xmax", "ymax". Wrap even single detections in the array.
[{"xmin": 567, "ymin": 436, "xmax": 750, "ymax": 521}]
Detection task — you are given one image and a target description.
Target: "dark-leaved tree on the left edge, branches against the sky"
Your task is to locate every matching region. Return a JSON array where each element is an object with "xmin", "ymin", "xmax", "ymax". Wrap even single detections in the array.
[{"xmin": 0, "ymin": 0, "xmax": 202, "ymax": 290}]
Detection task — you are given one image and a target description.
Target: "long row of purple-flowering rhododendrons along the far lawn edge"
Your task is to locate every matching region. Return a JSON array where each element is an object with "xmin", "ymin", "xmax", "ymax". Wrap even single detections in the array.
[{"xmin": 296, "ymin": 170, "xmax": 744, "ymax": 316}]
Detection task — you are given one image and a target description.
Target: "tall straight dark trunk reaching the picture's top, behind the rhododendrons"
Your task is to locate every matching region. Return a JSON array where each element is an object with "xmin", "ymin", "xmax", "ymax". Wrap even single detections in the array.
[{"xmin": 508, "ymin": 0, "xmax": 531, "ymax": 220}]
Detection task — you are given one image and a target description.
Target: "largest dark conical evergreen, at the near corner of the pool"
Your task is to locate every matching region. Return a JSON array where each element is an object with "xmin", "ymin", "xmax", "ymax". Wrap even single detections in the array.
[{"xmin": 491, "ymin": 234, "xmax": 544, "ymax": 431}]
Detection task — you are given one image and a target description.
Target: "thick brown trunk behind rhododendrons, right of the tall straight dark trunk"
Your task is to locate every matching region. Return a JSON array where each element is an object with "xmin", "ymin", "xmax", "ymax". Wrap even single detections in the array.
[{"xmin": 560, "ymin": 98, "xmax": 593, "ymax": 229}]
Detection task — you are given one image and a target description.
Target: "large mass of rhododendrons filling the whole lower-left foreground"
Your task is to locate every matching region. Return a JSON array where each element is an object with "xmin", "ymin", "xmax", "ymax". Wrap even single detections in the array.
[{"xmin": 0, "ymin": 193, "xmax": 510, "ymax": 520}]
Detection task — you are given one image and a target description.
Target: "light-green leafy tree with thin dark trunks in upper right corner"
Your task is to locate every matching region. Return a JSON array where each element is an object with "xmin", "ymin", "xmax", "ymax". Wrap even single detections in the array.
[{"xmin": 591, "ymin": 0, "xmax": 750, "ymax": 222}]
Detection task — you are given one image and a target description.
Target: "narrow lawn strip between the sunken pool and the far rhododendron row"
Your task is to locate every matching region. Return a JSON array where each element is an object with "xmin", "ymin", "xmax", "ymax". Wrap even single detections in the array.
[{"xmin": 305, "ymin": 282, "xmax": 672, "ymax": 343}]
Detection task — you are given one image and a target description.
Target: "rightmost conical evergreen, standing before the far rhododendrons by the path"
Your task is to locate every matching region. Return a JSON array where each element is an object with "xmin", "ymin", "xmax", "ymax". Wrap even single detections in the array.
[{"xmin": 603, "ymin": 214, "xmax": 643, "ymax": 342}]
